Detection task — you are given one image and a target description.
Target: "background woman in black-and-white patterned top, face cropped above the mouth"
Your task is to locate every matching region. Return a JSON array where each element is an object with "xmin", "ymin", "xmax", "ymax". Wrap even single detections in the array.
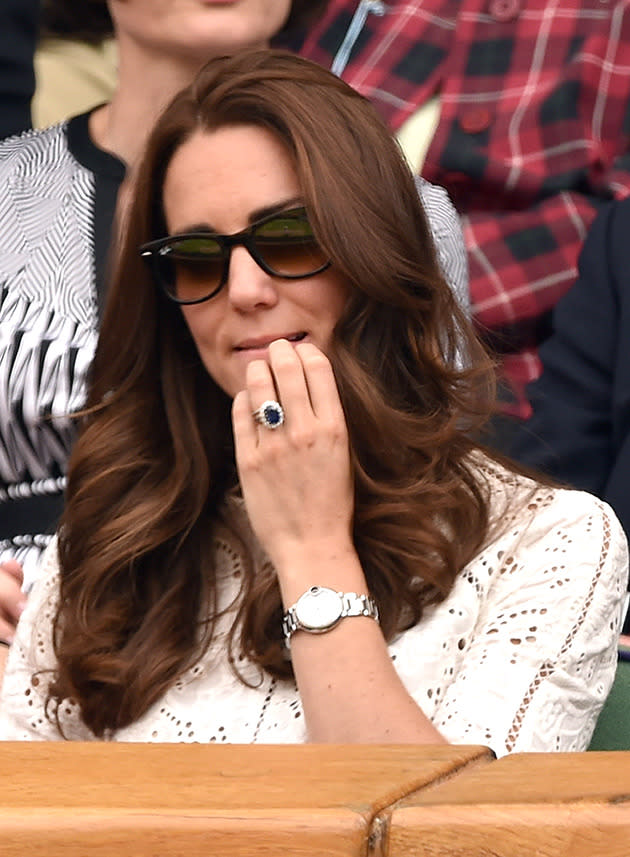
[{"xmin": 0, "ymin": 0, "xmax": 467, "ymax": 641}]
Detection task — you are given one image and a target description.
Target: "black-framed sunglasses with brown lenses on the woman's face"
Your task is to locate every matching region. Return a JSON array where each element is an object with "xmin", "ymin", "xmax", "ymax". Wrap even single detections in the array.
[{"xmin": 140, "ymin": 207, "xmax": 330, "ymax": 304}]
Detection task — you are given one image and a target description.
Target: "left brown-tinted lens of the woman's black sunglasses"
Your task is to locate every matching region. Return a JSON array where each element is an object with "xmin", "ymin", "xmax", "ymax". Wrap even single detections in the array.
[{"xmin": 159, "ymin": 235, "xmax": 224, "ymax": 302}]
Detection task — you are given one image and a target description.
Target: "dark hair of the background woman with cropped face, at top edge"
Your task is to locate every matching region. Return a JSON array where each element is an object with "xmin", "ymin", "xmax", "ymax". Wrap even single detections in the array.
[{"xmin": 40, "ymin": 0, "xmax": 328, "ymax": 44}]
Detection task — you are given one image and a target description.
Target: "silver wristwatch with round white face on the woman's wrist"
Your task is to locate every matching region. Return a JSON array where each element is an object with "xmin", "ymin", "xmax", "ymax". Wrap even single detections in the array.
[{"xmin": 282, "ymin": 586, "xmax": 378, "ymax": 646}]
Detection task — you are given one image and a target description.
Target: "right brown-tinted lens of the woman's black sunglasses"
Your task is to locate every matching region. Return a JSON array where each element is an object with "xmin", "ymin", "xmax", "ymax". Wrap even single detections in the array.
[{"xmin": 253, "ymin": 212, "xmax": 328, "ymax": 277}]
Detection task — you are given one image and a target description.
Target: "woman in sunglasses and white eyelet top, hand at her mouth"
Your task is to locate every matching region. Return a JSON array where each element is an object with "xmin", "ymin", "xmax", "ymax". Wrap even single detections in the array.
[{"xmin": 0, "ymin": 51, "xmax": 627, "ymax": 754}]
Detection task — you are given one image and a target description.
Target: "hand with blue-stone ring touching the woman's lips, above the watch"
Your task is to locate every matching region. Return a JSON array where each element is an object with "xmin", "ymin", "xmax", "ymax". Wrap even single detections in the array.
[{"xmin": 232, "ymin": 339, "xmax": 354, "ymax": 582}]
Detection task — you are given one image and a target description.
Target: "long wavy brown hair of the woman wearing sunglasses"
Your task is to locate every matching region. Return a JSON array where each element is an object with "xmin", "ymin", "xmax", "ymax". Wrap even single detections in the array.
[{"xmin": 49, "ymin": 51, "xmax": 502, "ymax": 736}]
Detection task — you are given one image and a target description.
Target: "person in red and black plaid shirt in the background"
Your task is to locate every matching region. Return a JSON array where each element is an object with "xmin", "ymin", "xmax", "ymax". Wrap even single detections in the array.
[{"xmin": 291, "ymin": 0, "xmax": 630, "ymax": 426}]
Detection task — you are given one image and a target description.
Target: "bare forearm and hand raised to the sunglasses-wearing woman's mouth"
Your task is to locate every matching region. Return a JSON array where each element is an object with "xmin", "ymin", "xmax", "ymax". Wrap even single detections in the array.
[{"xmin": 232, "ymin": 340, "xmax": 443, "ymax": 743}]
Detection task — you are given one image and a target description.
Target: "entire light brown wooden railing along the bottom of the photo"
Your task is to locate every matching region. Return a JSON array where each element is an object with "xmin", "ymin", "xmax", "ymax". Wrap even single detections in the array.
[{"xmin": 0, "ymin": 743, "xmax": 630, "ymax": 857}]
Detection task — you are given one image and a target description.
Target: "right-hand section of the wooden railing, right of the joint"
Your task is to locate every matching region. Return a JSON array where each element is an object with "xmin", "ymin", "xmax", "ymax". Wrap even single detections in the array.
[{"xmin": 388, "ymin": 752, "xmax": 630, "ymax": 857}]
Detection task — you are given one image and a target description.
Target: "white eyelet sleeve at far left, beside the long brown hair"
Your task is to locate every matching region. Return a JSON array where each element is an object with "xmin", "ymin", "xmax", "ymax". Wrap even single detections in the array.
[{"xmin": 0, "ymin": 539, "xmax": 93, "ymax": 741}]
